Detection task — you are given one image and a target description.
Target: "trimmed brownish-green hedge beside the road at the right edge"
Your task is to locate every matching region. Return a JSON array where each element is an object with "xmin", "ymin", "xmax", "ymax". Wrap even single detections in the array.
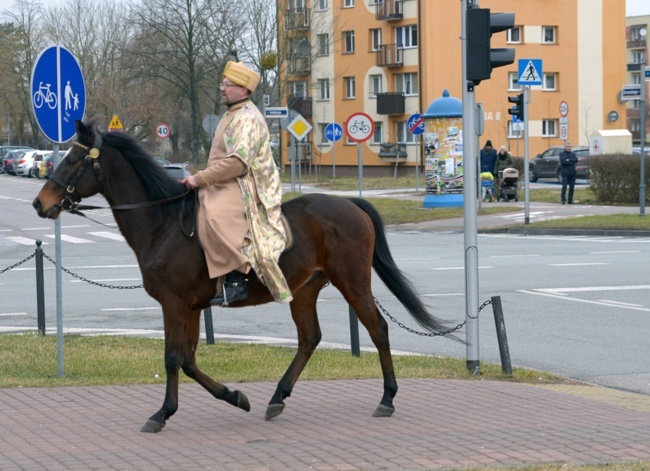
[{"xmin": 589, "ymin": 154, "xmax": 650, "ymax": 204}]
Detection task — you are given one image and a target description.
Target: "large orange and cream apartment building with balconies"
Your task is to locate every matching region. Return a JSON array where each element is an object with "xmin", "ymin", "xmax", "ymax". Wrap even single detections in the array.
[{"xmin": 278, "ymin": 0, "xmax": 629, "ymax": 175}]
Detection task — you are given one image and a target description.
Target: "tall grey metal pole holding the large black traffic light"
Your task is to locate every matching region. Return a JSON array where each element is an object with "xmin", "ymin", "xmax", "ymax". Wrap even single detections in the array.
[{"xmin": 461, "ymin": 0, "xmax": 481, "ymax": 375}]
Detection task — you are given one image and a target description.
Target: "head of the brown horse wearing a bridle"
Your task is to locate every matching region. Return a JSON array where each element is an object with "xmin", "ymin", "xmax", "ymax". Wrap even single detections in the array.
[{"xmin": 32, "ymin": 121, "xmax": 102, "ymax": 219}]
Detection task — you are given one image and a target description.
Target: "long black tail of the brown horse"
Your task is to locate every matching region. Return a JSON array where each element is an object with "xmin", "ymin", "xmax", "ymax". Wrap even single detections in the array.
[{"xmin": 350, "ymin": 198, "xmax": 458, "ymax": 340}]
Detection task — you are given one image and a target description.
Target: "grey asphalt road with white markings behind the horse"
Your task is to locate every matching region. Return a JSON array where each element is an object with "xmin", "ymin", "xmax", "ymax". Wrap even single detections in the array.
[{"xmin": 0, "ymin": 175, "xmax": 650, "ymax": 395}]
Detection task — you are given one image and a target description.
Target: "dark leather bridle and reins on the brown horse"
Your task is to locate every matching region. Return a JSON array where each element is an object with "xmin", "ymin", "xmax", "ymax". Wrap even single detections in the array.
[{"xmin": 49, "ymin": 133, "xmax": 194, "ymax": 238}]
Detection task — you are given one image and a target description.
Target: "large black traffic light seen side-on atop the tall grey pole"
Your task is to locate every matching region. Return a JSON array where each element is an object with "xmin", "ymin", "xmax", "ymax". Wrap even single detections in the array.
[{"xmin": 465, "ymin": 7, "xmax": 515, "ymax": 85}]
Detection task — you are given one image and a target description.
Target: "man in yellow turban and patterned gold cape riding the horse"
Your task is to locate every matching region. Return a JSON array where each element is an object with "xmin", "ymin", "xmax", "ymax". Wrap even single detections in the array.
[{"xmin": 182, "ymin": 61, "xmax": 293, "ymax": 306}]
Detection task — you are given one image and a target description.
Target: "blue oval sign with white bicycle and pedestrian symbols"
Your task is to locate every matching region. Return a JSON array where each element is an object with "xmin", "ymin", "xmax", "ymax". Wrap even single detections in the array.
[{"xmin": 30, "ymin": 46, "xmax": 86, "ymax": 144}]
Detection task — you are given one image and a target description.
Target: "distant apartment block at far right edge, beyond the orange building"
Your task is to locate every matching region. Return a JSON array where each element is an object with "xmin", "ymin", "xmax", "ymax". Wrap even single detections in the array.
[{"xmin": 625, "ymin": 16, "xmax": 650, "ymax": 145}]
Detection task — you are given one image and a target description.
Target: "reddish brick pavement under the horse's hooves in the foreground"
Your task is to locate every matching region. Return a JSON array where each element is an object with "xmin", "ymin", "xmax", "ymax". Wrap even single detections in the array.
[{"xmin": 0, "ymin": 379, "xmax": 650, "ymax": 471}]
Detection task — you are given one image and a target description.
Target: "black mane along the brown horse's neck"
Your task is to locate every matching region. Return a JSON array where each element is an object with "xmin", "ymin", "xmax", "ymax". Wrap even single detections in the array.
[{"xmin": 102, "ymin": 132, "xmax": 185, "ymax": 201}]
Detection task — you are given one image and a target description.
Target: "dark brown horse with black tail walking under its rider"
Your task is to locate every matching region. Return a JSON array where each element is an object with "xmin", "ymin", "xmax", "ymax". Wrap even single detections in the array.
[{"xmin": 33, "ymin": 121, "xmax": 456, "ymax": 432}]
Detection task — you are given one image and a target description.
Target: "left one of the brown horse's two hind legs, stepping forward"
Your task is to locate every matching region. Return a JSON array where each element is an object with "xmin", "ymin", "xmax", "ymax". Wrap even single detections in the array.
[{"xmin": 265, "ymin": 282, "xmax": 324, "ymax": 420}]
